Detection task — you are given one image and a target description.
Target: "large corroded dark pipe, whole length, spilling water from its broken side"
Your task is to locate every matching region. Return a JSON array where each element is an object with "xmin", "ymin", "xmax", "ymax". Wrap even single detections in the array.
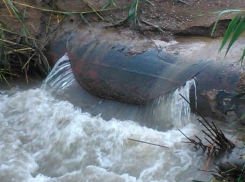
[{"xmin": 46, "ymin": 29, "xmax": 245, "ymax": 122}]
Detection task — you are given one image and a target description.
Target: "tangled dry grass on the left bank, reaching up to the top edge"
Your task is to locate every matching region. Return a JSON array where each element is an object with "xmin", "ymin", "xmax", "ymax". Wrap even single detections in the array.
[{"xmin": 0, "ymin": 0, "xmax": 50, "ymax": 83}]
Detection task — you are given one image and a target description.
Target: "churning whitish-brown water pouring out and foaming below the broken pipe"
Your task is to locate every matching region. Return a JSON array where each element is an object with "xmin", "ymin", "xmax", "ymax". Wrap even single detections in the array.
[{"xmin": 0, "ymin": 54, "xmax": 211, "ymax": 182}]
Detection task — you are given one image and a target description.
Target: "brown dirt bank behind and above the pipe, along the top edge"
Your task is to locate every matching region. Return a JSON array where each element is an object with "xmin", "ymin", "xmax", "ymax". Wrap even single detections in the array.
[{"xmin": 0, "ymin": 0, "xmax": 245, "ymax": 42}]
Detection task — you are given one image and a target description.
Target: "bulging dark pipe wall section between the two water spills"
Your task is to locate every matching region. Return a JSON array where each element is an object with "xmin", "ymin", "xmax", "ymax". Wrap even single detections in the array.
[{"xmin": 67, "ymin": 32, "xmax": 207, "ymax": 105}]
